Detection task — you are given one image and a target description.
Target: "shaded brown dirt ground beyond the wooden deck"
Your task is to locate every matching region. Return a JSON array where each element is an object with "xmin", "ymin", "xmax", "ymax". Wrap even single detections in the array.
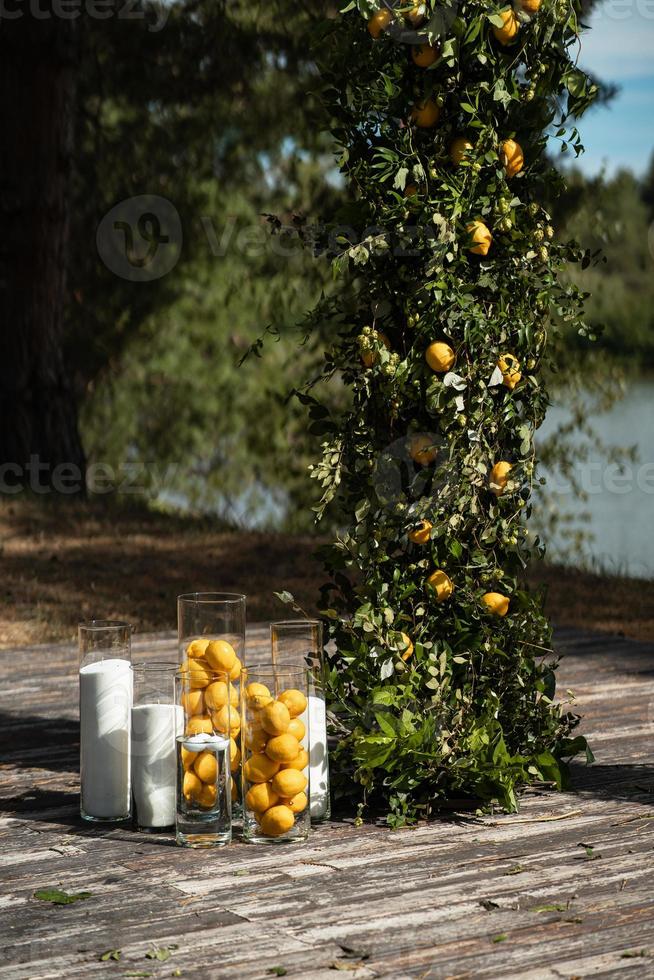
[{"xmin": 0, "ymin": 500, "xmax": 654, "ymax": 649}]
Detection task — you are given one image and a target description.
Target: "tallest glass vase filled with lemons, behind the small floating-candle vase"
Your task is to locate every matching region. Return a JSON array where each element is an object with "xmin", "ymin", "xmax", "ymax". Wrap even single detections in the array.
[{"xmin": 177, "ymin": 592, "xmax": 246, "ymax": 817}]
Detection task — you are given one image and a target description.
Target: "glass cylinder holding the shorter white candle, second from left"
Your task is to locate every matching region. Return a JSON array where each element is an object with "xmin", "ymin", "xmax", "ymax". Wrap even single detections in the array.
[{"xmin": 131, "ymin": 663, "xmax": 184, "ymax": 831}]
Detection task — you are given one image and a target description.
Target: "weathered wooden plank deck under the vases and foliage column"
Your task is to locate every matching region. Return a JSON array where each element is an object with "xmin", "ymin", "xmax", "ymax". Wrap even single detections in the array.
[{"xmin": 0, "ymin": 628, "xmax": 654, "ymax": 980}]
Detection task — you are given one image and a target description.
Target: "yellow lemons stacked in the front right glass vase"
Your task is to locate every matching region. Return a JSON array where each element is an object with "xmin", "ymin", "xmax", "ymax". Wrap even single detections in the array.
[{"xmin": 243, "ymin": 683, "xmax": 309, "ymax": 837}]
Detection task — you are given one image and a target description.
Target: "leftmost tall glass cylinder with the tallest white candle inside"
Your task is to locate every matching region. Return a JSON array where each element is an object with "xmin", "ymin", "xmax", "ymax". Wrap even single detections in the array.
[{"xmin": 78, "ymin": 620, "xmax": 132, "ymax": 822}]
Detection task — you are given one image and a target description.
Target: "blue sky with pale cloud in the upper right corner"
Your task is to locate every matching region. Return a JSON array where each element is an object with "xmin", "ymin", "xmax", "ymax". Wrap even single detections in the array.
[{"xmin": 577, "ymin": 0, "xmax": 654, "ymax": 174}]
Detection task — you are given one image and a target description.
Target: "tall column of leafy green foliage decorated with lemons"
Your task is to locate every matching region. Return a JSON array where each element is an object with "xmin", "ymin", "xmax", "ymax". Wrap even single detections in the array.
[{"xmin": 305, "ymin": 0, "xmax": 597, "ymax": 826}]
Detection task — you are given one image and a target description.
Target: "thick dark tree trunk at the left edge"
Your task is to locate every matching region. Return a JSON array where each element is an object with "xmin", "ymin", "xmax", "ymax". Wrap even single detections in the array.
[{"xmin": 0, "ymin": 2, "xmax": 84, "ymax": 493}]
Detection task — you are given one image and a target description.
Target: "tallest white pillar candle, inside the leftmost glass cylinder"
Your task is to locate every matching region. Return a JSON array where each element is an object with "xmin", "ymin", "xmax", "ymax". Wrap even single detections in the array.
[{"xmin": 79, "ymin": 658, "xmax": 132, "ymax": 820}]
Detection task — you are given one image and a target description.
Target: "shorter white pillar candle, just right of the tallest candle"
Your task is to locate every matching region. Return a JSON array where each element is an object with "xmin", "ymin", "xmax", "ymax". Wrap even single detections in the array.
[{"xmin": 132, "ymin": 704, "xmax": 184, "ymax": 827}]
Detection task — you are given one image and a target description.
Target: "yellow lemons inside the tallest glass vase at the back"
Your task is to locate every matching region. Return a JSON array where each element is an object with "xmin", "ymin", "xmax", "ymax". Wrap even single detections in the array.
[{"xmin": 180, "ymin": 639, "xmax": 242, "ymax": 807}]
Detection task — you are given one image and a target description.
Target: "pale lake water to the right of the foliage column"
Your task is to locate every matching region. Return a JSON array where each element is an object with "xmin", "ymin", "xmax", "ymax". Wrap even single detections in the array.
[{"xmin": 540, "ymin": 379, "xmax": 654, "ymax": 578}]
